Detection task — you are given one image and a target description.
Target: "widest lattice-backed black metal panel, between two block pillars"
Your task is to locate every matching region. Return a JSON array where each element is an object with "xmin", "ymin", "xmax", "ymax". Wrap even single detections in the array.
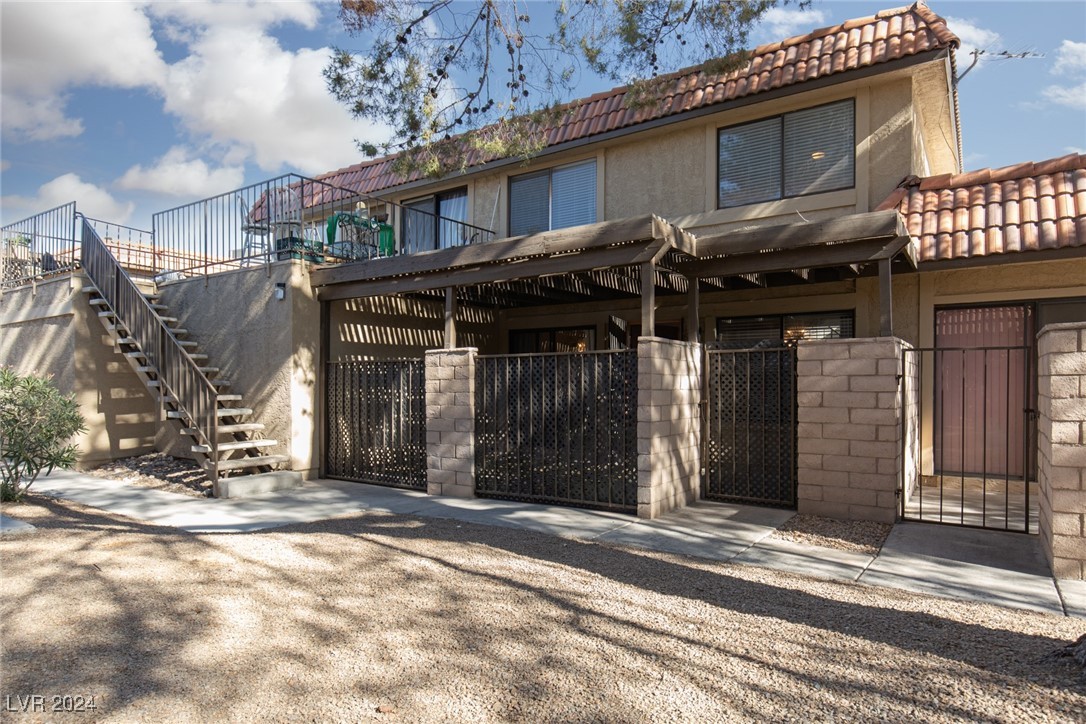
[{"xmin": 476, "ymin": 351, "xmax": 637, "ymax": 511}]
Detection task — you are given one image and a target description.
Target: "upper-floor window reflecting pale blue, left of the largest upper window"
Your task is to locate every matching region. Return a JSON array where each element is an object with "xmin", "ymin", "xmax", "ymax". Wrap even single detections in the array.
[{"xmin": 509, "ymin": 158, "xmax": 596, "ymax": 237}]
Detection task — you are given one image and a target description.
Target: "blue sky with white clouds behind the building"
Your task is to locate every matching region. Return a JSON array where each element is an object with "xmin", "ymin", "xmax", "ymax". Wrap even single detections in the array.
[{"xmin": 0, "ymin": 0, "xmax": 1086, "ymax": 228}]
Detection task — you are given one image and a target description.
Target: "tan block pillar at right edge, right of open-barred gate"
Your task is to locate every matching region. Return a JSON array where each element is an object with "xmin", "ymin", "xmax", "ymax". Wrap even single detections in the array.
[{"xmin": 1037, "ymin": 322, "xmax": 1086, "ymax": 580}]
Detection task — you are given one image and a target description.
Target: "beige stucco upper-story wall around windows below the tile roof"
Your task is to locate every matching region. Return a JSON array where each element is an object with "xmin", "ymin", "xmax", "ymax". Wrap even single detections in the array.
[{"xmin": 392, "ymin": 62, "xmax": 933, "ymax": 238}]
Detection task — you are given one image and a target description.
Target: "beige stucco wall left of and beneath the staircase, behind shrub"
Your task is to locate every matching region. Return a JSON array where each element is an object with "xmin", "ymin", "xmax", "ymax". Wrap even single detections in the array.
[{"xmin": 0, "ymin": 275, "xmax": 157, "ymax": 468}]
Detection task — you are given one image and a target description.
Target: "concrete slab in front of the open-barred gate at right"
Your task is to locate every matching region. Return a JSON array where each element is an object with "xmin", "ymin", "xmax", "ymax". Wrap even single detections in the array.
[{"xmin": 860, "ymin": 522, "xmax": 1064, "ymax": 614}]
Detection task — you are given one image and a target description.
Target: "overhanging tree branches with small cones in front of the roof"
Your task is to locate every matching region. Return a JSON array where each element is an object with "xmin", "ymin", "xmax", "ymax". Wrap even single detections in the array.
[{"xmin": 324, "ymin": 0, "xmax": 810, "ymax": 176}]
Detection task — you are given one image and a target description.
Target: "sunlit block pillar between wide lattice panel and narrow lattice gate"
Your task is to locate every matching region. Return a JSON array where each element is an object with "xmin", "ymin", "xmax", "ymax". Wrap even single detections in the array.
[{"xmin": 637, "ymin": 336, "xmax": 703, "ymax": 518}]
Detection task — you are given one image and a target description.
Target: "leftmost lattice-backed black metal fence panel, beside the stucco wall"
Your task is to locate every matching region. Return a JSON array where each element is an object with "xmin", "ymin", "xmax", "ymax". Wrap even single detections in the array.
[{"xmin": 325, "ymin": 359, "xmax": 426, "ymax": 491}]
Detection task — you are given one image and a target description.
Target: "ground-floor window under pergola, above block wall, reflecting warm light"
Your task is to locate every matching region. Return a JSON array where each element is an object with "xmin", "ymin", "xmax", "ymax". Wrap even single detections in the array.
[{"xmin": 717, "ymin": 310, "xmax": 856, "ymax": 350}]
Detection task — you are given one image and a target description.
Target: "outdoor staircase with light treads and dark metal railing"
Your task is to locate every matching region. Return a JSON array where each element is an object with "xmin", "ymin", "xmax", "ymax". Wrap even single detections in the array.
[{"xmin": 81, "ymin": 214, "xmax": 301, "ymax": 497}]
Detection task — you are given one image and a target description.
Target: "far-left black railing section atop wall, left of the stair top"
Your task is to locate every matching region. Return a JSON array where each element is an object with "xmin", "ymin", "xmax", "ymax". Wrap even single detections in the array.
[{"xmin": 0, "ymin": 201, "xmax": 79, "ymax": 289}]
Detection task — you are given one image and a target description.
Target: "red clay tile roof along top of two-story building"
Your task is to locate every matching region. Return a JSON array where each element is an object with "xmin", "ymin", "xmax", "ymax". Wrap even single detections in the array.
[{"xmin": 318, "ymin": 2, "xmax": 959, "ymax": 198}]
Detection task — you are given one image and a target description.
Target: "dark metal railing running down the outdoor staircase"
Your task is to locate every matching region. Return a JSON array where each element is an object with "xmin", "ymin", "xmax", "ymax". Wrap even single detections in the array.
[{"xmin": 79, "ymin": 214, "xmax": 218, "ymax": 480}]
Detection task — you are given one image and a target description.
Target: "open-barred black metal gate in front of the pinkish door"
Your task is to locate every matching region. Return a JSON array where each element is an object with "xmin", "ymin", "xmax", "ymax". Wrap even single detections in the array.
[{"xmin": 900, "ymin": 345, "xmax": 1038, "ymax": 533}]
